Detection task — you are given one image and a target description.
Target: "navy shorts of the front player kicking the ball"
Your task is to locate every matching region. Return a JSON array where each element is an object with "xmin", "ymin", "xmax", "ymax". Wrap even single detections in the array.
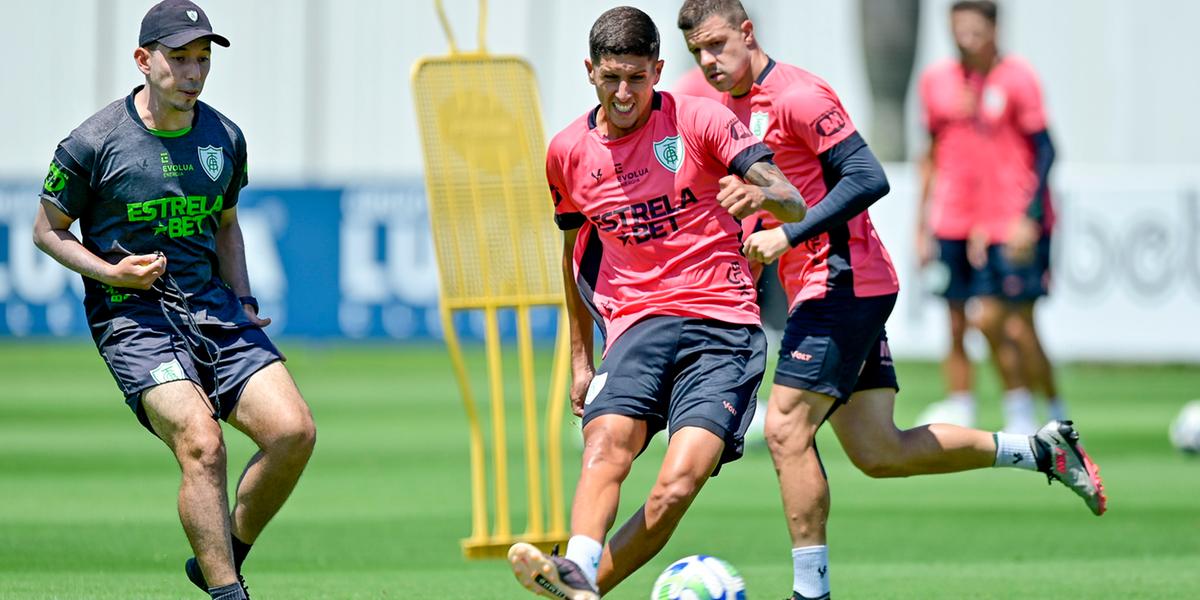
[{"xmin": 583, "ymin": 316, "xmax": 767, "ymax": 463}]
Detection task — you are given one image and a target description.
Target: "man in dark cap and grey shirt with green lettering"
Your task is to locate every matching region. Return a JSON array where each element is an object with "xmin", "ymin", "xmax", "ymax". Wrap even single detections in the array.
[{"xmin": 34, "ymin": 0, "xmax": 316, "ymax": 599}]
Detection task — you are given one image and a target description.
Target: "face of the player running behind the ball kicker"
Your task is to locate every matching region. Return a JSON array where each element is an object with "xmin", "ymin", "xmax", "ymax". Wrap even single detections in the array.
[{"xmin": 684, "ymin": 14, "xmax": 754, "ymax": 92}]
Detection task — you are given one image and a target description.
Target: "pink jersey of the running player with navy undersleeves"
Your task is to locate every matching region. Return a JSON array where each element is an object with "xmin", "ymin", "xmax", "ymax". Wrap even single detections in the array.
[{"xmin": 724, "ymin": 60, "xmax": 900, "ymax": 308}]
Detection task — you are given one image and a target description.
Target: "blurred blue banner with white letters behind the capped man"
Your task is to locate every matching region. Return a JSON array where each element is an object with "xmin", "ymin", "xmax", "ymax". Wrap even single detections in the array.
[{"xmin": 0, "ymin": 181, "xmax": 557, "ymax": 341}]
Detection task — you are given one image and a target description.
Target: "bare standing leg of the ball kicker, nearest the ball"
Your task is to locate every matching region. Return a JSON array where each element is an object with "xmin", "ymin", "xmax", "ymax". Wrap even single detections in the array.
[{"xmin": 596, "ymin": 427, "xmax": 725, "ymax": 594}]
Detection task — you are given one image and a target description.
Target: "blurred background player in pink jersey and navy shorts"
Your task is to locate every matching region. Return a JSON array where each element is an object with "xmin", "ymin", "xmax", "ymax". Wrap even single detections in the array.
[{"xmin": 917, "ymin": 0, "xmax": 1066, "ymax": 433}]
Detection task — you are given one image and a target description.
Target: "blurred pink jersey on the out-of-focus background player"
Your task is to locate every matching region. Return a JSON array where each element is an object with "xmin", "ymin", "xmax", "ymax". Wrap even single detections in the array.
[{"xmin": 919, "ymin": 56, "xmax": 1052, "ymax": 244}]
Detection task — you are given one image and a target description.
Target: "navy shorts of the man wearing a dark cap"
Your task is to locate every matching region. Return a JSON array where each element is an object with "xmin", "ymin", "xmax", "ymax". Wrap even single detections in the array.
[{"xmin": 96, "ymin": 324, "xmax": 284, "ymax": 433}]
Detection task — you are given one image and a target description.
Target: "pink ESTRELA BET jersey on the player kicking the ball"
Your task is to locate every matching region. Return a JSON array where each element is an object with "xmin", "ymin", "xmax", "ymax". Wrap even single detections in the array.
[{"xmin": 546, "ymin": 92, "xmax": 770, "ymax": 350}]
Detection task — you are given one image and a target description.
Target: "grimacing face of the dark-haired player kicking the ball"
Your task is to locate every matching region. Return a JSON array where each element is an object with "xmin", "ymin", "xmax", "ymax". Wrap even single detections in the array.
[{"xmin": 584, "ymin": 54, "xmax": 662, "ymax": 137}]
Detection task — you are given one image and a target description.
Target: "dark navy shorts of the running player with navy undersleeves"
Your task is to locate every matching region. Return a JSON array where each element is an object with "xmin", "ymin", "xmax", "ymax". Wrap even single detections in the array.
[{"xmin": 775, "ymin": 294, "xmax": 900, "ymax": 403}]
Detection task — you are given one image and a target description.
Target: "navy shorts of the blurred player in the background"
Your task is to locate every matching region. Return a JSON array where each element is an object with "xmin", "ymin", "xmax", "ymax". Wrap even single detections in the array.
[{"xmin": 937, "ymin": 236, "xmax": 1050, "ymax": 302}]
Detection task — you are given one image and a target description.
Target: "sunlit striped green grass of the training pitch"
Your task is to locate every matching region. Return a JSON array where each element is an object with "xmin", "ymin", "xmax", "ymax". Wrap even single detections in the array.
[{"xmin": 0, "ymin": 340, "xmax": 1200, "ymax": 600}]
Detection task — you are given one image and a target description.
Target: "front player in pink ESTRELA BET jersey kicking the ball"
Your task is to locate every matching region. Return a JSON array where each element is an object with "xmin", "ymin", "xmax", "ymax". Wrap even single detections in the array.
[{"xmin": 509, "ymin": 7, "xmax": 805, "ymax": 600}]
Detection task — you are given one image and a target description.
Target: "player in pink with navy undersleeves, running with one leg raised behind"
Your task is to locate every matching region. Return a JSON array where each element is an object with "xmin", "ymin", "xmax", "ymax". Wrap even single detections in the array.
[{"xmin": 678, "ymin": 0, "xmax": 1106, "ymax": 599}]
